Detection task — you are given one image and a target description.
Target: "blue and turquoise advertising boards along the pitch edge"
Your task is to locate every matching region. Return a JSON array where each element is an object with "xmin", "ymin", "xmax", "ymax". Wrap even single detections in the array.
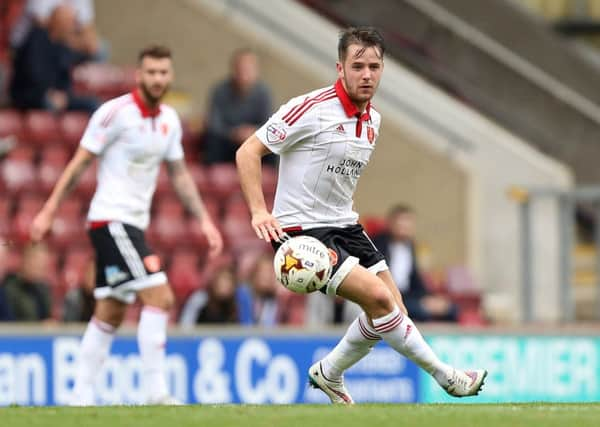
[{"xmin": 0, "ymin": 327, "xmax": 600, "ymax": 406}]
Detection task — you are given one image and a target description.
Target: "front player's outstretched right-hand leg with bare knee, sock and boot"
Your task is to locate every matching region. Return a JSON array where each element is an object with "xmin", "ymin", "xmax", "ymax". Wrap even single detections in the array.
[{"xmin": 337, "ymin": 265, "xmax": 487, "ymax": 397}]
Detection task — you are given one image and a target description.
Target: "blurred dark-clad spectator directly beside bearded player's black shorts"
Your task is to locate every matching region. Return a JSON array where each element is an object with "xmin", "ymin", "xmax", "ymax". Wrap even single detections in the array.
[{"xmin": 63, "ymin": 261, "xmax": 96, "ymax": 323}]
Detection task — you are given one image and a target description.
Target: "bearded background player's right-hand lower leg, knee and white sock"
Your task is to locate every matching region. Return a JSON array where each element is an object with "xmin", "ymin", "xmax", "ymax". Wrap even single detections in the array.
[{"xmin": 137, "ymin": 284, "xmax": 177, "ymax": 404}]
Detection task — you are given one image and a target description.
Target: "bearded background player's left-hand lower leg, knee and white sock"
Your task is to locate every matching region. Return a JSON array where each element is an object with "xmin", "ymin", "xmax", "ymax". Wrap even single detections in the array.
[{"xmin": 71, "ymin": 298, "xmax": 127, "ymax": 406}]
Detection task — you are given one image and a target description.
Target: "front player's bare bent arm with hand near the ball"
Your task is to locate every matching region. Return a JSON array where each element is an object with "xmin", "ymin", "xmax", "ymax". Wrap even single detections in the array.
[{"xmin": 235, "ymin": 135, "xmax": 283, "ymax": 242}]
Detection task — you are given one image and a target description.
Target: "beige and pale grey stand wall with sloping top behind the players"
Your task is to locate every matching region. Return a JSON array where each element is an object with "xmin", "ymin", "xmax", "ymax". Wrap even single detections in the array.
[{"xmin": 97, "ymin": 0, "xmax": 572, "ymax": 321}]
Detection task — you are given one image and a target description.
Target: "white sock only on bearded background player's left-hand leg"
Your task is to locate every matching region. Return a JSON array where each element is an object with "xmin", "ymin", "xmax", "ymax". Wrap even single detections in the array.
[{"xmin": 71, "ymin": 317, "xmax": 115, "ymax": 406}]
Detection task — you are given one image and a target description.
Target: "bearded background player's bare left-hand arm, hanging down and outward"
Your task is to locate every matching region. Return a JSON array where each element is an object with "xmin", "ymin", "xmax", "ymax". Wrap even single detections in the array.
[{"xmin": 30, "ymin": 147, "xmax": 96, "ymax": 242}]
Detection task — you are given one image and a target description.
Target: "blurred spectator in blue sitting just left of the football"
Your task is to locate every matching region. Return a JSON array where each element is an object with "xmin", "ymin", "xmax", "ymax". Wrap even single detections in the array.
[{"xmin": 238, "ymin": 254, "xmax": 304, "ymax": 327}]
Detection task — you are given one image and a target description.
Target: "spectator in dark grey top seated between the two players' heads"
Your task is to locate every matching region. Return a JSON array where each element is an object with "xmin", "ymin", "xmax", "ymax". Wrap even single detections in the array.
[{"xmin": 203, "ymin": 48, "xmax": 275, "ymax": 164}]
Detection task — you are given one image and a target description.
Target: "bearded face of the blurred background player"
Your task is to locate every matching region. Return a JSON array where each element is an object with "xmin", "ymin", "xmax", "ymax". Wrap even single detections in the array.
[{"xmin": 136, "ymin": 56, "xmax": 173, "ymax": 103}]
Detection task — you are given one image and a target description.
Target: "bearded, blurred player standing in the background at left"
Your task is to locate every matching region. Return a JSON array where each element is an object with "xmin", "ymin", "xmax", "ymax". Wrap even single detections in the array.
[{"xmin": 31, "ymin": 46, "xmax": 223, "ymax": 405}]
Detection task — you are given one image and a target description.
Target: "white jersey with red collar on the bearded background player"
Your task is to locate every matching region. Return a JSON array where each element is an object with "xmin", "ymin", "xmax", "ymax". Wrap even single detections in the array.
[{"xmin": 81, "ymin": 91, "xmax": 183, "ymax": 230}]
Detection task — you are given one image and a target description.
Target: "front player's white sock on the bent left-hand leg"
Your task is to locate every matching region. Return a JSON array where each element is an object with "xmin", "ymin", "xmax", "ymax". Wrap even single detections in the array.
[{"xmin": 321, "ymin": 313, "xmax": 381, "ymax": 379}]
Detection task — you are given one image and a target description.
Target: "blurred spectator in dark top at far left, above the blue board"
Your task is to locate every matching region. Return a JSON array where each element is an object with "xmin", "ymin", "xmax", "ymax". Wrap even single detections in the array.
[{"xmin": 0, "ymin": 243, "xmax": 52, "ymax": 322}]
